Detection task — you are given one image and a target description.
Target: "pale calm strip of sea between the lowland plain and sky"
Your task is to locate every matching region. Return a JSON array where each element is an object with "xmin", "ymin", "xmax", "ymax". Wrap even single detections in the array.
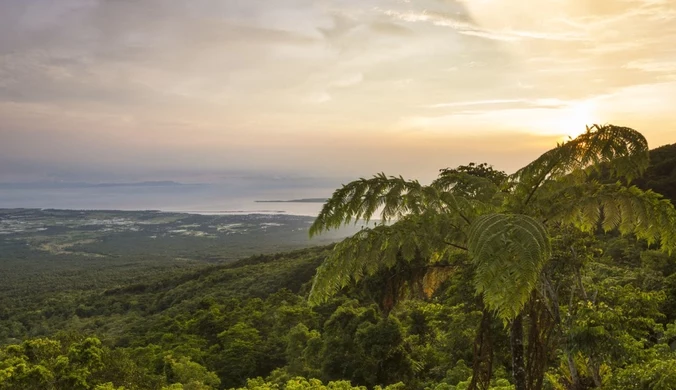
[{"xmin": 0, "ymin": 182, "xmax": 335, "ymax": 216}]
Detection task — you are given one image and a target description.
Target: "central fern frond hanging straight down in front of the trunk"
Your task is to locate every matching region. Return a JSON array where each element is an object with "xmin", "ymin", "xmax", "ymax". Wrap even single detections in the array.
[{"xmin": 467, "ymin": 214, "xmax": 551, "ymax": 320}]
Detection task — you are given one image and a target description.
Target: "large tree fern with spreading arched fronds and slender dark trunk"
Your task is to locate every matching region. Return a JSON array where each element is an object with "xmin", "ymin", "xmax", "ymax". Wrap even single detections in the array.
[{"xmin": 310, "ymin": 125, "xmax": 676, "ymax": 390}]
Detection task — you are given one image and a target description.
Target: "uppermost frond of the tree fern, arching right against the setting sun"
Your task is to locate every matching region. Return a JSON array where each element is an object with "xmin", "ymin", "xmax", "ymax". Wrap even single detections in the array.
[{"xmin": 509, "ymin": 125, "xmax": 649, "ymax": 210}]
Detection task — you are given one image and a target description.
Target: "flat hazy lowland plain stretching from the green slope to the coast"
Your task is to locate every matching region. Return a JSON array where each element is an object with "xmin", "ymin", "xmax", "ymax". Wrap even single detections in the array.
[{"xmin": 0, "ymin": 209, "xmax": 356, "ymax": 344}]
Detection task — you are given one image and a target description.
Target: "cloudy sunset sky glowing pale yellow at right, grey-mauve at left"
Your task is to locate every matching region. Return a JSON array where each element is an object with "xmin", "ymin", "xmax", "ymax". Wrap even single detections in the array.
[{"xmin": 0, "ymin": 0, "xmax": 676, "ymax": 182}]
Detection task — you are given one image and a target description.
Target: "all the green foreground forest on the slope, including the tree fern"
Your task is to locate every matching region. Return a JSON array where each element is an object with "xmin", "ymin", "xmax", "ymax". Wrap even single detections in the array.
[{"xmin": 0, "ymin": 126, "xmax": 676, "ymax": 390}]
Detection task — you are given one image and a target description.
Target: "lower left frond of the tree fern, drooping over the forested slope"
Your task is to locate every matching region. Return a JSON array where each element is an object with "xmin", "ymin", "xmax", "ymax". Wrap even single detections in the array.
[{"xmin": 309, "ymin": 212, "xmax": 465, "ymax": 304}]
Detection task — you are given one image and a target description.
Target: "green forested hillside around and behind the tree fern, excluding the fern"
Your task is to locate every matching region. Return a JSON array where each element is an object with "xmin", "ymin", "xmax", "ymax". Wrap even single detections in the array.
[{"xmin": 0, "ymin": 145, "xmax": 676, "ymax": 390}]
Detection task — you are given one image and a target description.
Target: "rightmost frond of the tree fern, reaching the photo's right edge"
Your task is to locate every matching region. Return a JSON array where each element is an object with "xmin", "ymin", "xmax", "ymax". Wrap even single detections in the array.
[{"xmin": 548, "ymin": 182, "xmax": 676, "ymax": 253}]
